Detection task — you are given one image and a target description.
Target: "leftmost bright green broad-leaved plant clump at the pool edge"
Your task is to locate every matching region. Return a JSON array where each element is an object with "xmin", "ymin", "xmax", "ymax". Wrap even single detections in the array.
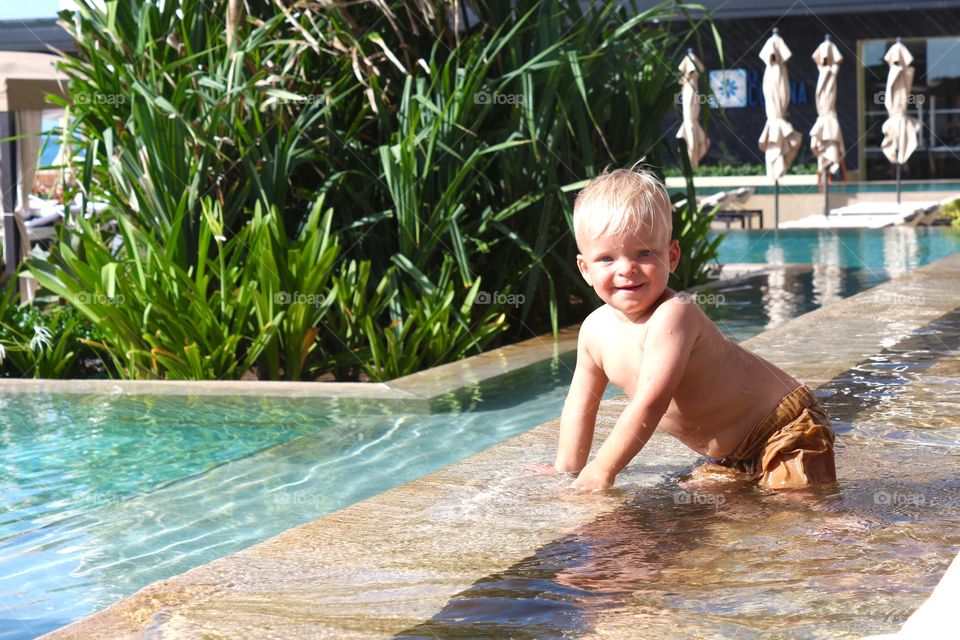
[{"xmin": 28, "ymin": 200, "xmax": 283, "ymax": 379}]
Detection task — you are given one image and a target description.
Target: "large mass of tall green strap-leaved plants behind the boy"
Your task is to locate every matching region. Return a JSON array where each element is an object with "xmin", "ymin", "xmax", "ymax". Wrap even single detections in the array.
[{"xmin": 24, "ymin": 0, "xmax": 720, "ymax": 379}]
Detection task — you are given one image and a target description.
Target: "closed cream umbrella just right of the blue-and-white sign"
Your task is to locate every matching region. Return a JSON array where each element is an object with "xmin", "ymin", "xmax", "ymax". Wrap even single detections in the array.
[{"xmin": 759, "ymin": 29, "xmax": 803, "ymax": 228}]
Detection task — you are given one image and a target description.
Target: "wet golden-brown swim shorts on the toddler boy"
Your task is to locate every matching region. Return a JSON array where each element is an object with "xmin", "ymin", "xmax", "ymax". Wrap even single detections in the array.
[{"xmin": 717, "ymin": 385, "xmax": 837, "ymax": 489}]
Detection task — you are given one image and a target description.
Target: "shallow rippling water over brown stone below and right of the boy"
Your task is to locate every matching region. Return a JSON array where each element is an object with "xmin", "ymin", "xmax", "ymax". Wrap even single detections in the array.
[{"xmin": 399, "ymin": 309, "xmax": 960, "ymax": 638}]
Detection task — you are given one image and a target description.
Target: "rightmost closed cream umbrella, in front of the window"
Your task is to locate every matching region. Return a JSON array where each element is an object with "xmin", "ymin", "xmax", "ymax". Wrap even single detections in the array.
[{"xmin": 880, "ymin": 38, "xmax": 920, "ymax": 204}]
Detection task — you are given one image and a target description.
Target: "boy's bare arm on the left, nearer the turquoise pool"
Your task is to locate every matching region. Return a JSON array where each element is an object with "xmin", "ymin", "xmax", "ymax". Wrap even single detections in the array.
[{"xmin": 553, "ymin": 319, "xmax": 607, "ymax": 473}]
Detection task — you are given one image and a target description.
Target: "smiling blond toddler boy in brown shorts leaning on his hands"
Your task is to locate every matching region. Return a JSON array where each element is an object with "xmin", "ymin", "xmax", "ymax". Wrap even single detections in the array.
[{"xmin": 554, "ymin": 169, "xmax": 836, "ymax": 490}]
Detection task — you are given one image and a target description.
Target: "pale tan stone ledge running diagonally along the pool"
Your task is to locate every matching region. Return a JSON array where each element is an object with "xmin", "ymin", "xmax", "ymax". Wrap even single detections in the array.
[{"xmin": 43, "ymin": 254, "xmax": 960, "ymax": 640}]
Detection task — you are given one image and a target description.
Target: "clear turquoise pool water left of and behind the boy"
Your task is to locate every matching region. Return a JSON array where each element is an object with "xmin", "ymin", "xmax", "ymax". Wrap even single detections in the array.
[{"xmin": 0, "ymin": 230, "xmax": 956, "ymax": 639}]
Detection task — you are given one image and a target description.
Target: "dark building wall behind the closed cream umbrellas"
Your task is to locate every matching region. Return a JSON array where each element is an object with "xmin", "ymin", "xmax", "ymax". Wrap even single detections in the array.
[{"xmin": 667, "ymin": 9, "xmax": 960, "ymax": 169}]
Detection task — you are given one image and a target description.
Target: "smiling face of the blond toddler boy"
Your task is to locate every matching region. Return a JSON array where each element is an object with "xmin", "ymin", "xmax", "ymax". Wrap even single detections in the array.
[{"xmin": 577, "ymin": 221, "xmax": 680, "ymax": 320}]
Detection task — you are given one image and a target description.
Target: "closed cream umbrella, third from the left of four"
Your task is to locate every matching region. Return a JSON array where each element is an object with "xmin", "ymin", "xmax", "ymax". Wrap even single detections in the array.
[{"xmin": 810, "ymin": 35, "xmax": 845, "ymax": 215}]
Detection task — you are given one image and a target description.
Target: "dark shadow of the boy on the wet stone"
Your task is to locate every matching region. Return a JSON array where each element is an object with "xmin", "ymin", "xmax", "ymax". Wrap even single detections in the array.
[{"xmin": 398, "ymin": 484, "xmax": 744, "ymax": 639}]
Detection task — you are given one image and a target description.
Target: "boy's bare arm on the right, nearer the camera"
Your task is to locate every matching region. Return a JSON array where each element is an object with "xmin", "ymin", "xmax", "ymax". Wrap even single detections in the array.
[{"xmin": 573, "ymin": 301, "xmax": 699, "ymax": 490}]
